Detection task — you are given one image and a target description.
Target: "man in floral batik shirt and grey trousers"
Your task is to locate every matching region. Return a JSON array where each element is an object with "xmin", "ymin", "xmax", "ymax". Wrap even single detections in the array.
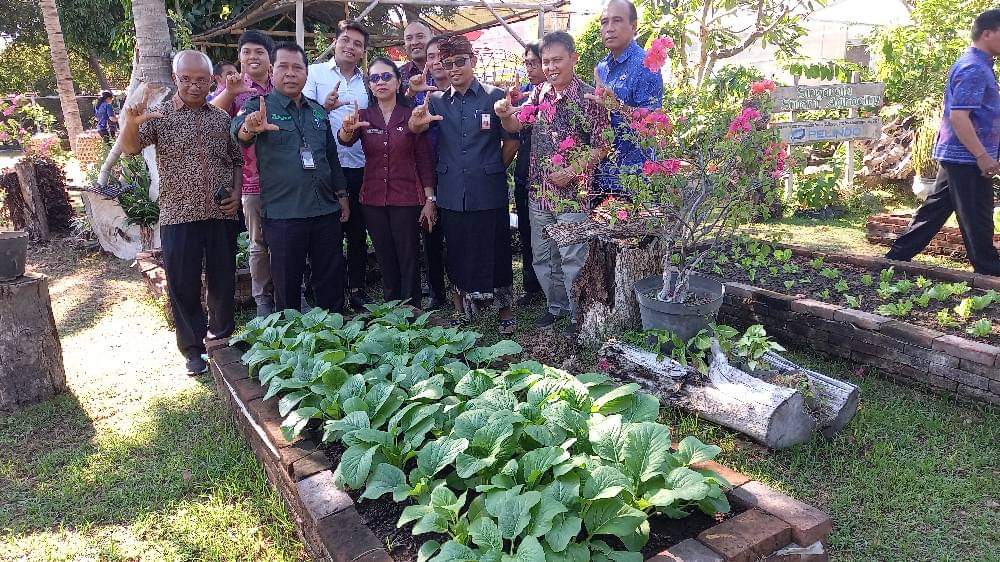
[{"xmin": 495, "ymin": 31, "xmax": 610, "ymax": 327}]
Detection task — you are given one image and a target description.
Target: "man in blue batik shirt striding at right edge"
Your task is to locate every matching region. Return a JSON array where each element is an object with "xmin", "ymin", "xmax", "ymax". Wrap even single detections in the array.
[{"xmin": 886, "ymin": 6, "xmax": 1000, "ymax": 275}]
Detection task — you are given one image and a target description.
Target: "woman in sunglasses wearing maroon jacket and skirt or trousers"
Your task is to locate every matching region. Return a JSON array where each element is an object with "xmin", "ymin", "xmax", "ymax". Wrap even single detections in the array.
[{"xmin": 337, "ymin": 57, "xmax": 437, "ymax": 307}]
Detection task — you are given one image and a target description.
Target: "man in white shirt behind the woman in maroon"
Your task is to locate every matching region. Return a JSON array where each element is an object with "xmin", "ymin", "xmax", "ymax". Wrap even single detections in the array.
[{"xmin": 302, "ymin": 21, "xmax": 371, "ymax": 312}]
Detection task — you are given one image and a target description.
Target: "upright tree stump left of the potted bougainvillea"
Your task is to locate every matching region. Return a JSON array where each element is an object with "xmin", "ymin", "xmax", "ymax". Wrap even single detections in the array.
[{"xmin": 573, "ymin": 237, "xmax": 663, "ymax": 344}]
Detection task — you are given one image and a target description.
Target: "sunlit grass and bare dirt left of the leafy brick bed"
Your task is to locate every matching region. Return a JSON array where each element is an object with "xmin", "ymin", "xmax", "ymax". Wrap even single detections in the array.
[{"xmin": 0, "ymin": 243, "xmax": 304, "ymax": 562}]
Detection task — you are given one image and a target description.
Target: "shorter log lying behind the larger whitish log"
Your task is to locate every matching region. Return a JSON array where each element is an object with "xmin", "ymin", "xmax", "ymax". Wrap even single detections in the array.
[{"xmin": 762, "ymin": 351, "xmax": 861, "ymax": 438}]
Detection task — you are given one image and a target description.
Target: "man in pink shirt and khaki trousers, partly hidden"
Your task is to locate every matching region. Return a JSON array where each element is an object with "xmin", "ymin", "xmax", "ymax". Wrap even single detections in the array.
[{"xmin": 212, "ymin": 30, "xmax": 274, "ymax": 316}]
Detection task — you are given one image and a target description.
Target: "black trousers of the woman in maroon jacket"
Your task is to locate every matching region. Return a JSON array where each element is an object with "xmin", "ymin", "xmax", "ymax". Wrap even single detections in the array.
[{"xmin": 361, "ymin": 205, "xmax": 420, "ymax": 307}]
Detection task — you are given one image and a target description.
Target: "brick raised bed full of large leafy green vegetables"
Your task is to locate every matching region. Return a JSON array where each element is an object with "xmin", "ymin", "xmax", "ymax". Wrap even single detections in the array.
[{"xmin": 212, "ymin": 311, "xmax": 830, "ymax": 561}]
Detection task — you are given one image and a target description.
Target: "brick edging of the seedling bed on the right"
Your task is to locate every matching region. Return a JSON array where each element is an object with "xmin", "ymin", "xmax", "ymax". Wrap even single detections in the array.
[{"xmin": 719, "ymin": 244, "xmax": 1000, "ymax": 404}]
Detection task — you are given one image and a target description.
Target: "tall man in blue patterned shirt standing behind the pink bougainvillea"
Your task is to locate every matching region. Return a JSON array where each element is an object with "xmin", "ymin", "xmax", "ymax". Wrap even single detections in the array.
[{"xmin": 594, "ymin": 0, "xmax": 663, "ymax": 197}]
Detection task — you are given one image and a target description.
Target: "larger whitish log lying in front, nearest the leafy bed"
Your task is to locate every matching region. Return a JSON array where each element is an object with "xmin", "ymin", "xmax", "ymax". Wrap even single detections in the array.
[{"xmin": 599, "ymin": 341, "xmax": 816, "ymax": 449}]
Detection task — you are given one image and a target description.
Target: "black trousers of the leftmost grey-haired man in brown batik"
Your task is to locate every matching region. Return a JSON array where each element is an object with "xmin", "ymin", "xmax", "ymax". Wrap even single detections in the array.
[{"xmin": 160, "ymin": 219, "xmax": 240, "ymax": 359}]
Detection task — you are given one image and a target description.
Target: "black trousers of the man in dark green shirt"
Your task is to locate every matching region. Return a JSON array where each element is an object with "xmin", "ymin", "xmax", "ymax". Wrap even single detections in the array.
[{"xmin": 261, "ymin": 211, "xmax": 353, "ymax": 312}]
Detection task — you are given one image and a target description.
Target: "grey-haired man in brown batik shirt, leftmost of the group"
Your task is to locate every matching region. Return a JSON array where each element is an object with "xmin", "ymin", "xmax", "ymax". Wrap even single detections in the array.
[{"xmin": 121, "ymin": 51, "xmax": 243, "ymax": 374}]
